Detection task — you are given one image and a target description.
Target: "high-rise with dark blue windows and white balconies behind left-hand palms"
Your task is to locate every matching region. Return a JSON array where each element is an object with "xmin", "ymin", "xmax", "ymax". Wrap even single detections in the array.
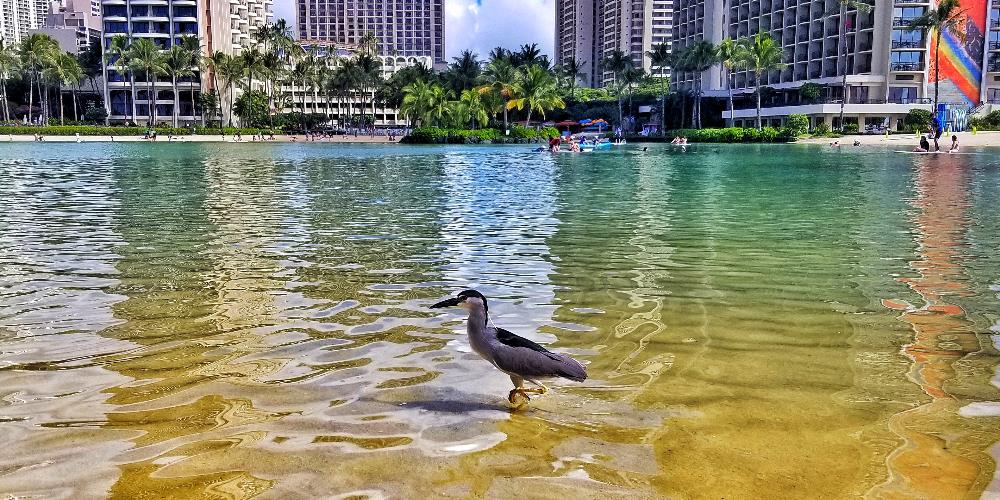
[{"xmin": 101, "ymin": 0, "xmax": 273, "ymax": 124}]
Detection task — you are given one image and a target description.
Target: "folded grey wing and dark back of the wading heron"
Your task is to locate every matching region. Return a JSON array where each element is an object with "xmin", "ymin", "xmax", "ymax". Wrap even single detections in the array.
[{"xmin": 493, "ymin": 328, "xmax": 587, "ymax": 382}]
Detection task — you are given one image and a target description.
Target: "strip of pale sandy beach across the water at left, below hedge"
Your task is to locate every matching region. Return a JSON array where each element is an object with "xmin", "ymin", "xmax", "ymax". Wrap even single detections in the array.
[{"xmin": 0, "ymin": 134, "xmax": 400, "ymax": 144}]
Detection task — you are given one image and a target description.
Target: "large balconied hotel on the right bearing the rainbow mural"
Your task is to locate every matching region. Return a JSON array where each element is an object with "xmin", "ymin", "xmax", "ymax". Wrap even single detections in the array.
[{"xmin": 671, "ymin": 0, "xmax": 1000, "ymax": 132}]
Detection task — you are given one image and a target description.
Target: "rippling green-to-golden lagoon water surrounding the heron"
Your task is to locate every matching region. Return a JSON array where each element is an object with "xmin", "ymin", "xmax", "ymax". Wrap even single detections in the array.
[{"xmin": 0, "ymin": 144, "xmax": 1000, "ymax": 499}]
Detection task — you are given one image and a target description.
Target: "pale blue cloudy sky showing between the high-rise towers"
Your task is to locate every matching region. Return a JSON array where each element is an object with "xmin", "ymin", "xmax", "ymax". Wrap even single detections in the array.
[{"xmin": 274, "ymin": 0, "xmax": 555, "ymax": 59}]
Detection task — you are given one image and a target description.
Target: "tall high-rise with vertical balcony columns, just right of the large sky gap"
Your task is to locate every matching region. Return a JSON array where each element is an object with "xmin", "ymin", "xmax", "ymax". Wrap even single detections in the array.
[{"xmin": 555, "ymin": 0, "xmax": 673, "ymax": 87}]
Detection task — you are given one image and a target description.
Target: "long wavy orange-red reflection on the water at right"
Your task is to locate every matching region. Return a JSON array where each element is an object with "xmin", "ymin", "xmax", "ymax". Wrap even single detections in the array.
[{"xmin": 879, "ymin": 157, "xmax": 980, "ymax": 498}]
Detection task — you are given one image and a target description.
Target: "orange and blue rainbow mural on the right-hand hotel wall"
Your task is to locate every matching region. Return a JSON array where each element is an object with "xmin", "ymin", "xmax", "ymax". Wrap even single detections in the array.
[{"xmin": 927, "ymin": 0, "xmax": 989, "ymax": 106}]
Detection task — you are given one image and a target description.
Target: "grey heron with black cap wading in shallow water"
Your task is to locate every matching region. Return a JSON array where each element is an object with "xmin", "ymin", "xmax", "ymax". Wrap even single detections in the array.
[{"xmin": 430, "ymin": 290, "xmax": 587, "ymax": 404}]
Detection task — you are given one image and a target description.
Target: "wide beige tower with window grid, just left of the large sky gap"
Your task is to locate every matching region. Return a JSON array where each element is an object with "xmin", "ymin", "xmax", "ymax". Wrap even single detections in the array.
[{"xmin": 296, "ymin": 0, "xmax": 447, "ymax": 64}]
